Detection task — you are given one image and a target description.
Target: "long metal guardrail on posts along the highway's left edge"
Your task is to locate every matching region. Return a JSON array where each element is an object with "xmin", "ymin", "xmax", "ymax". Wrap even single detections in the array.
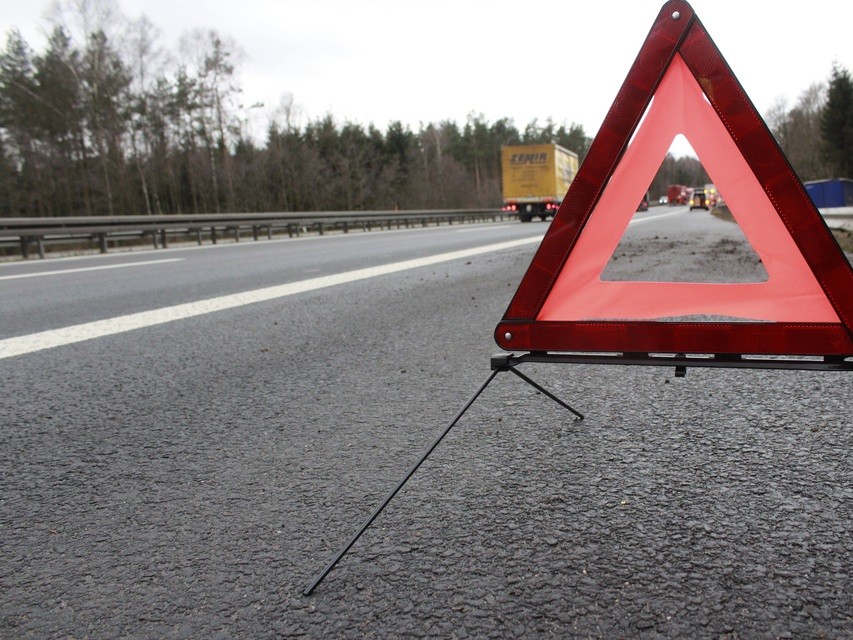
[{"xmin": 0, "ymin": 209, "xmax": 510, "ymax": 259}]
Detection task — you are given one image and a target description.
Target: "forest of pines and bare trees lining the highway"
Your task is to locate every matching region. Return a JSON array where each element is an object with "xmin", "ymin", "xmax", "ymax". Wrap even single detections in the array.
[{"xmin": 0, "ymin": 3, "xmax": 853, "ymax": 217}]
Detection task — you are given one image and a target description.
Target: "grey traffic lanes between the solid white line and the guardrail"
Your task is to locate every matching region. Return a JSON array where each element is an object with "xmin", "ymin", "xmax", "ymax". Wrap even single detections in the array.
[{"xmin": 0, "ymin": 208, "xmax": 683, "ymax": 339}]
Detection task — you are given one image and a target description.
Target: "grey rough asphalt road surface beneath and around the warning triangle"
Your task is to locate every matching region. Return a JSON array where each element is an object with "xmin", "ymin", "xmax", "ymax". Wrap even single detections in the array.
[{"xmin": 0, "ymin": 209, "xmax": 853, "ymax": 638}]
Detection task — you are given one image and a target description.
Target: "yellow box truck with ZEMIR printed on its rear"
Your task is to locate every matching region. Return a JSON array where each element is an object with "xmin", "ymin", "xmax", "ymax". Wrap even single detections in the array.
[{"xmin": 501, "ymin": 144, "xmax": 578, "ymax": 222}]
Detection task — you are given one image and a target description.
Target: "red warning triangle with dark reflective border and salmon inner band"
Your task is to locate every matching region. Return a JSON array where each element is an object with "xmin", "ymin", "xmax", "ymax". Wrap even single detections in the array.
[{"xmin": 495, "ymin": 0, "xmax": 853, "ymax": 356}]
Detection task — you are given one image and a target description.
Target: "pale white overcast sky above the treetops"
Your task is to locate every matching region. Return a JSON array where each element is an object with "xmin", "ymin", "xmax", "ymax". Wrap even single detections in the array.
[{"xmin": 0, "ymin": 0, "xmax": 853, "ymax": 151}]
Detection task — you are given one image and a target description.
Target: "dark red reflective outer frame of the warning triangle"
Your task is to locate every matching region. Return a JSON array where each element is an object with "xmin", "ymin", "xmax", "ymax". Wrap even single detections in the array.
[{"xmin": 495, "ymin": 0, "xmax": 853, "ymax": 357}]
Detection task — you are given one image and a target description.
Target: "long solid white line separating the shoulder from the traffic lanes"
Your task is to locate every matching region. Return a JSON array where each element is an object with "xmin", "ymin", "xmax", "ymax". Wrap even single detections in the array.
[{"xmin": 0, "ymin": 236, "xmax": 542, "ymax": 360}]
